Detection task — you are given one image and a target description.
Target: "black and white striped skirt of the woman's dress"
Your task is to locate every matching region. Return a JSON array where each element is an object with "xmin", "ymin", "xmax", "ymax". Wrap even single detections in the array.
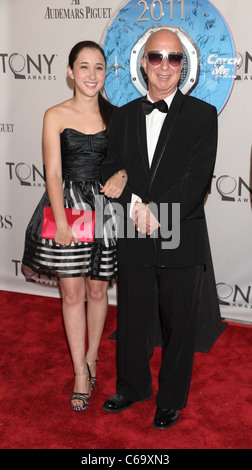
[{"xmin": 22, "ymin": 181, "xmax": 117, "ymax": 283}]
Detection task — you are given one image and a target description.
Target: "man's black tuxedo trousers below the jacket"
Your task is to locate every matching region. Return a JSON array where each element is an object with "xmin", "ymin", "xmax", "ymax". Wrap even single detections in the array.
[{"xmin": 116, "ymin": 263, "xmax": 203, "ymax": 409}]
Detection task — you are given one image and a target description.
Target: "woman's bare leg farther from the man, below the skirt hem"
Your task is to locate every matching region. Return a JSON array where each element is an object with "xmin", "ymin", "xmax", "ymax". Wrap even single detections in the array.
[{"xmin": 60, "ymin": 278, "xmax": 89, "ymax": 405}]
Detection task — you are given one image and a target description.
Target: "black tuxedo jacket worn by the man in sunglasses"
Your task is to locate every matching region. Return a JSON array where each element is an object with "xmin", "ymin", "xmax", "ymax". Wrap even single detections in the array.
[{"xmin": 101, "ymin": 90, "xmax": 217, "ymax": 267}]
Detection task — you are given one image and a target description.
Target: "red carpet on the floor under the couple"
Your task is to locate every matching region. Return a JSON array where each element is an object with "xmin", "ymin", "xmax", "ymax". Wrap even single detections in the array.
[{"xmin": 0, "ymin": 292, "xmax": 252, "ymax": 449}]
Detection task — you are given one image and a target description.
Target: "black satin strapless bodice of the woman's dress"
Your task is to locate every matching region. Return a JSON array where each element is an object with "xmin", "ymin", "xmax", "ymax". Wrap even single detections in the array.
[{"xmin": 60, "ymin": 128, "xmax": 107, "ymax": 181}]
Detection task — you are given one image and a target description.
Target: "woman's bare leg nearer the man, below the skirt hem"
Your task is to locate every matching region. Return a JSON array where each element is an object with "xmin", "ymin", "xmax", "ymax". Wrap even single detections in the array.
[{"xmin": 86, "ymin": 278, "xmax": 108, "ymax": 377}]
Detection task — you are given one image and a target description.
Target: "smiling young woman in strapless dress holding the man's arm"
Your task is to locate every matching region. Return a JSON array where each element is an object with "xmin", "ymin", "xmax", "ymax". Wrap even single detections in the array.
[{"xmin": 22, "ymin": 41, "xmax": 125, "ymax": 411}]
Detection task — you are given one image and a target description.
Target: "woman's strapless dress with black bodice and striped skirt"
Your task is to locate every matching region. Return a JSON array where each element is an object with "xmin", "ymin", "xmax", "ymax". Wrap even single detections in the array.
[{"xmin": 22, "ymin": 129, "xmax": 117, "ymax": 282}]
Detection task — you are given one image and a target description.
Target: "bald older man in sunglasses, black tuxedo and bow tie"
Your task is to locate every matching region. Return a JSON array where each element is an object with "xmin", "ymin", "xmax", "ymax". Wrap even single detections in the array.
[{"xmin": 99, "ymin": 29, "xmax": 217, "ymax": 429}]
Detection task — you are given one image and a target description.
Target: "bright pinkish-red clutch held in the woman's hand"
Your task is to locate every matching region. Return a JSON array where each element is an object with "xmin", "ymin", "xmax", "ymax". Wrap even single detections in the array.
[{"xmin": 41, "ymin": 206, "xmax": 95, "ymax": 242}]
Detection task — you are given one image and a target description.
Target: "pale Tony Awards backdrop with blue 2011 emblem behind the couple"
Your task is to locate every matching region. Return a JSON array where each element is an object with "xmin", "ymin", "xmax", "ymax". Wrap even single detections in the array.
[{"xmin": 0, "ymin": 0, "xmax": 252, "ymax": 321}]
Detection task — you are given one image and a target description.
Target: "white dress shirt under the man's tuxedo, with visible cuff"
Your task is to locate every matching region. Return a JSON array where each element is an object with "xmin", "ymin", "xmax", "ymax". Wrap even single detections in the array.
[{"xmin": 130, "ymin": 90, "xmax": 177, "ymax": 214}]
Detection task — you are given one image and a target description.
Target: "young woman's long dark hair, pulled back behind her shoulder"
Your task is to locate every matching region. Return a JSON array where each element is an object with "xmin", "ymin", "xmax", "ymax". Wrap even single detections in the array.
[{"xmin": 68, "ymin": 41, "xmax": 115, "ymax": 133}]
